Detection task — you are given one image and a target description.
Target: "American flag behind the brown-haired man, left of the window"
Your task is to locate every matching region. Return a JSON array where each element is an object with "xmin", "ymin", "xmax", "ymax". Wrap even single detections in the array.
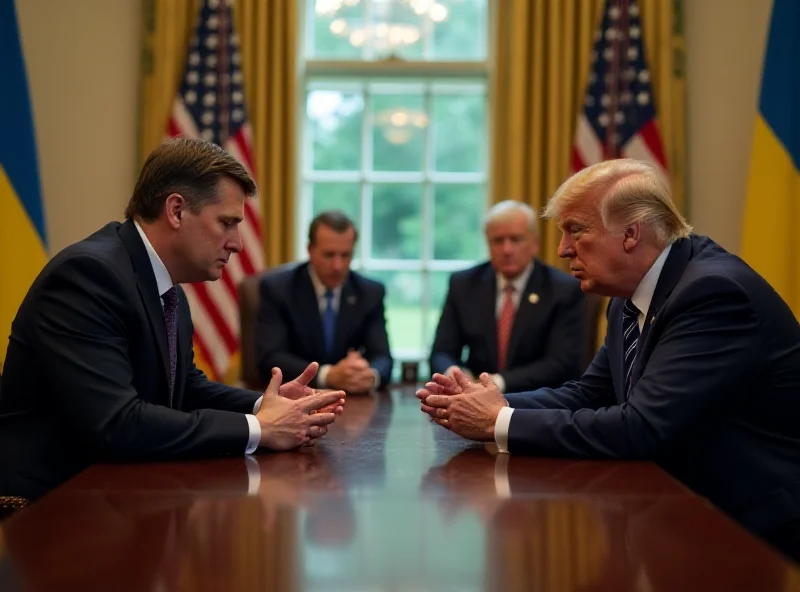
[{"xmin": 167, "ymin": 0, "xmax": 264, "ymax": 380}]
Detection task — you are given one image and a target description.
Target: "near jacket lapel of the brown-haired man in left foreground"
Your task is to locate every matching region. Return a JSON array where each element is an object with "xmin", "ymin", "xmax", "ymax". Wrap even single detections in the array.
[{"xmin": 119, "ymin": 220, "xmax": 169, "ymax": 400}]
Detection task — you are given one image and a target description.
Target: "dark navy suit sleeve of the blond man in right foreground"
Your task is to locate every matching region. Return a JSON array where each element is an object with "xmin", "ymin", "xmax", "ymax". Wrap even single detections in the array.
[{"xmin": 509, "ymin": 276, "xmax": 760, "ymax": 459}]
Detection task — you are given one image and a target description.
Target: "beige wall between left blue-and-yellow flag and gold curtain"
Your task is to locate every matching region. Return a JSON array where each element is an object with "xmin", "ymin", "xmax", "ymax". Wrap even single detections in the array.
[{"xmin": 16, "ymin": 0, "xmax": 141, "ymax": 253}]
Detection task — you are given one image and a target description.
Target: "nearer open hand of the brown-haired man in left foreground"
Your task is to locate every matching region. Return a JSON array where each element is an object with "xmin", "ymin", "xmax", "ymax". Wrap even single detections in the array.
[{"xmin": 256, "ymin": 368, "xmax": 345, "ymax": 450}]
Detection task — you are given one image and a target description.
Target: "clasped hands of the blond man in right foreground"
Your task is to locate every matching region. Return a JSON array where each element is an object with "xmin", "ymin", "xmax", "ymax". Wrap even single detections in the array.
[{"xmin": 417, "ymin": 370, "xmax": 506, "ymax": 441}]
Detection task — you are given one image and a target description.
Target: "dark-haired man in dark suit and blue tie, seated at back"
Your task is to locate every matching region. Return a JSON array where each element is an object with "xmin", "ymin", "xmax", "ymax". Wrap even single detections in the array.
[{"xmin": 256, "ymin": 211, "xmax": 392, "ymax": 392}]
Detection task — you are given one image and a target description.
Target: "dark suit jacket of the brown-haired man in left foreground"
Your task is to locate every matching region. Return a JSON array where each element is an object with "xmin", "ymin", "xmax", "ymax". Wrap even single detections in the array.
[{"xmin": 0, "ymin": 222, "xmax": 259, "ymax": 498}]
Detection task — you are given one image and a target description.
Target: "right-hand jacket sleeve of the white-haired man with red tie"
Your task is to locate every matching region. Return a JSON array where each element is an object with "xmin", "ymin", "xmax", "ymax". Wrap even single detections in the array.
[{"xmin": 500, "ymin": 284, "xmax": 587, "ymax": 393}]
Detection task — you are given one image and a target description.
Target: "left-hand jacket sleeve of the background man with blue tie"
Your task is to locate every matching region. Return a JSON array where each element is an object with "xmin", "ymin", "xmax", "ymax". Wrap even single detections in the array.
[{"xmin": 255, "ymin": 281, "xmax": 317, "ymax": 385}]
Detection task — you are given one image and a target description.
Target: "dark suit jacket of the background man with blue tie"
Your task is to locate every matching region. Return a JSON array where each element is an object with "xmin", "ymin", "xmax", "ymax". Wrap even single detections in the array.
[{"xmin": 256, "ymin": 263, "xmax": 392, "ymax": 385}]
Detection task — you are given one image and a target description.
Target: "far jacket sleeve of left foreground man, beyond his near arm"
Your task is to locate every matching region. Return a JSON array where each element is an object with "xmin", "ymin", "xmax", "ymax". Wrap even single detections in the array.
[{"xmin": 181, "ymin": 295, "xmax": 262, "ymax": 414}]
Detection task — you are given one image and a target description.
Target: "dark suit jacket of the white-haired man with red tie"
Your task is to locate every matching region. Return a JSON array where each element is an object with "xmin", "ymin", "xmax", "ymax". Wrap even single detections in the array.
[{"xmin": 430, "ymin": 260, "xmax": 587, "ymax": 392}]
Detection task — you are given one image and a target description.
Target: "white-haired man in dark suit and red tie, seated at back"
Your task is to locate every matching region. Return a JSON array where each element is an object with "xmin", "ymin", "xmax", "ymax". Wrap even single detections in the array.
[{"xmin": 430, "ymin": 200, "xmax": 587, "ymax": 392}]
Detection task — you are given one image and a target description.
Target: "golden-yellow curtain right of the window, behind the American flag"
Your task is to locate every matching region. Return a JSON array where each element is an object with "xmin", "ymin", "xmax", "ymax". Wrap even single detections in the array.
[{"xmin": 491, "ymin": 0, "xmax": 686, "ymax": 267}]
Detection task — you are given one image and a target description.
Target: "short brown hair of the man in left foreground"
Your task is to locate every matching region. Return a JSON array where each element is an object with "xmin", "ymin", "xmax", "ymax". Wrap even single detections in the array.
[{"xmin": 125, "ymin": 138, "xmax": 256, "ymax": 222}]
